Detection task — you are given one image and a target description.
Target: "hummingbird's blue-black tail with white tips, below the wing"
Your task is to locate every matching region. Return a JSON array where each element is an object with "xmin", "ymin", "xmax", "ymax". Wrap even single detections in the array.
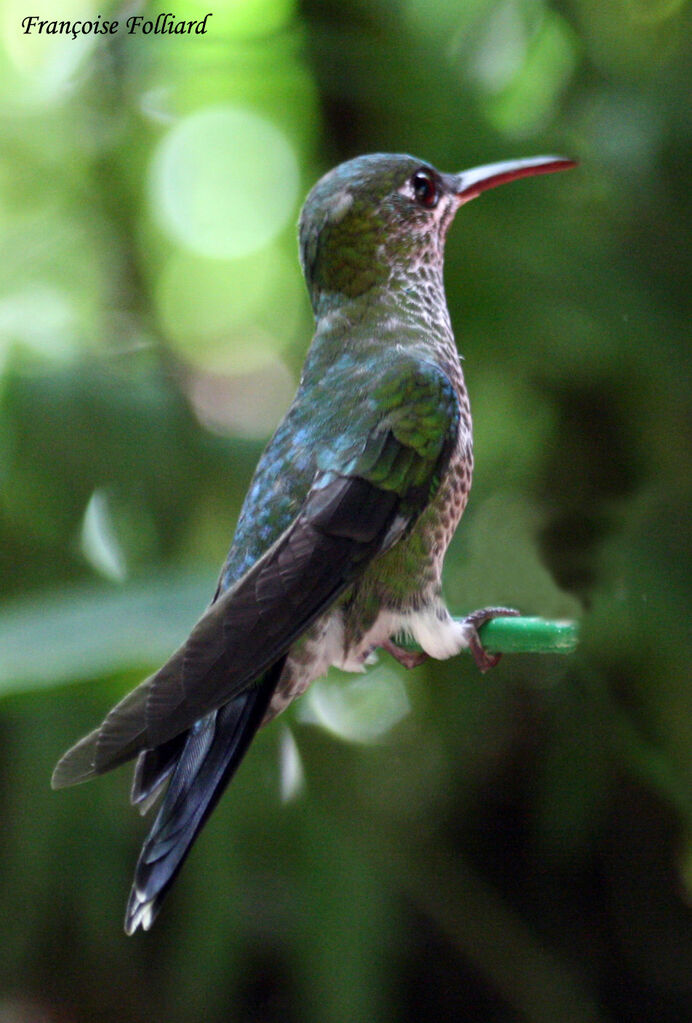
[{"xmin": 125, "ymin": 659, "xmax": 284, "ymax": 934}]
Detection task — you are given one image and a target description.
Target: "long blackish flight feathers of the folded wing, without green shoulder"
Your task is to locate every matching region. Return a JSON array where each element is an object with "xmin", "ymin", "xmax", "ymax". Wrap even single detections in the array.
[{"xmin": 52, "ymin": 476, "xmax": 398, "ymax": 788}]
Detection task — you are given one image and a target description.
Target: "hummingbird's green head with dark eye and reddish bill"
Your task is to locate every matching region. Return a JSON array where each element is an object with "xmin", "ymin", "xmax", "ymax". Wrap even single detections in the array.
[{"xmin": 299, "ymin": 153, "xmax": 574, "ymax": 312}]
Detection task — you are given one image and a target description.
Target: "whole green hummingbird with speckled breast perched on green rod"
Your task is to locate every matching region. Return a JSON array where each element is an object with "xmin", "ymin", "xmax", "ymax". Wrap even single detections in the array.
[{"xmin": 52, "ymin": 153, "xmax": 574, "ymax": 934}]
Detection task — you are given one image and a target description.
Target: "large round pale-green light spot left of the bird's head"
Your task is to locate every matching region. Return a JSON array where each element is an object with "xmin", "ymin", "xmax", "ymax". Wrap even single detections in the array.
[{"xmin": 152, "ymin": 106, "xmax": 299, "ymax": 259}]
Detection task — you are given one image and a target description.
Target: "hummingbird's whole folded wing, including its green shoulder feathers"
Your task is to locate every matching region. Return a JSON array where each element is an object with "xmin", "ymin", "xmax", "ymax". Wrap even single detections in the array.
[{"xmin": 53, "ymin": 360, "xmax": 459, "ymax": 788}]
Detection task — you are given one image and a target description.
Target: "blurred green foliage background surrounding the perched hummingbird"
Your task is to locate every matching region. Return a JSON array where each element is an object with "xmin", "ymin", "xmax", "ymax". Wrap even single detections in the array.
[{"xmin": 0, "ymin": 0, "xmax": 692, "ymax": 1023}]
